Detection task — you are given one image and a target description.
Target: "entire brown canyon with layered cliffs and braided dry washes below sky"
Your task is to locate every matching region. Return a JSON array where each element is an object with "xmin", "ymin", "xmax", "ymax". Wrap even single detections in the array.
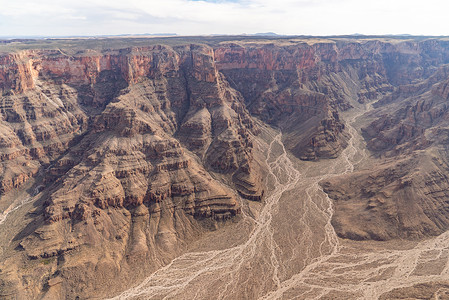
[{"xmin": 0, "ymin": 36, "xmax": 449, "ymax": 299}]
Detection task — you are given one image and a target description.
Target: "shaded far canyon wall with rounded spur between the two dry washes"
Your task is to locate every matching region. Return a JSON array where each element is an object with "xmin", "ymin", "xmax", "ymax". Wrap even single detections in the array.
[{"xmin": 214, "ymin": 41, "xmax": 449, "ymax": 160}]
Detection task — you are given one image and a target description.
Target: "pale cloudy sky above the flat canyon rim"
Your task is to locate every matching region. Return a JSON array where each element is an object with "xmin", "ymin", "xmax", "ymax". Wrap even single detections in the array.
[{"xmin": 0, "ymin": 0, "xmax": 449, "ymax": 37}]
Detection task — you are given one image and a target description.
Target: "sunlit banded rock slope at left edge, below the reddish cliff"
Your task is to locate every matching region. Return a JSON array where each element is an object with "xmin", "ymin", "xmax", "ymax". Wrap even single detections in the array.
[{"xmin": 0, "ymin": 83, "xmax": 88, "ymax": 193}]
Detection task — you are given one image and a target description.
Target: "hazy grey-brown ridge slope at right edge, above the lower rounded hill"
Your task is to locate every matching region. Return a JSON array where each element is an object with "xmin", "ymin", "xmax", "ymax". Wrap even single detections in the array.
[{"xmin": 362, "ymin": 66, "xmax": 449, "ymax": 156}]
